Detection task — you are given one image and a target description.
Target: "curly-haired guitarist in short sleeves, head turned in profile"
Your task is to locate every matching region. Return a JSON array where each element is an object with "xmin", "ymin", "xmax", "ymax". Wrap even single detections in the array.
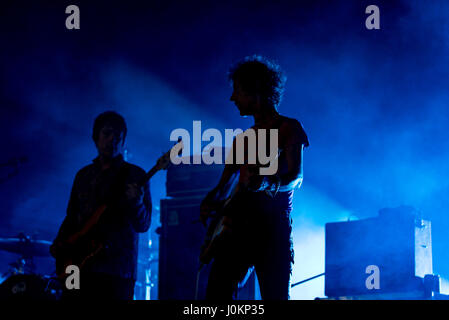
[{"xmin": 200, "ymin": 56, "xmax": 309, "ymax": 300}]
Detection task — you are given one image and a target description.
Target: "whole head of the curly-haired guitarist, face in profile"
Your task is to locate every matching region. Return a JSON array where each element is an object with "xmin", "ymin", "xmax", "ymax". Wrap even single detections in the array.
[{"xmin": 228, "ymin": 55, "xmax": 286, "ymax": 116}]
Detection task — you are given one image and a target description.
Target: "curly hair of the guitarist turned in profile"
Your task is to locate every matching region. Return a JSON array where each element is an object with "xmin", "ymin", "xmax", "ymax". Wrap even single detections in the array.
[{"xmin": 228, "ymin": 55, "xmax": 287, "ymax": 109}]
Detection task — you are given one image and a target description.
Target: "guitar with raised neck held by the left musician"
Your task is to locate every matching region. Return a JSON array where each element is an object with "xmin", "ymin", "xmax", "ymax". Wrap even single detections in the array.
[{"xmin": 56, "ymin": 141, "xmax": 183, "ymax": 279}]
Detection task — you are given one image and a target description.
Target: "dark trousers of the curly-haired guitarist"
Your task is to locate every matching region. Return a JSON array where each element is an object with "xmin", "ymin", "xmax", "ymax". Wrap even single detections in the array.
[{"xmin": 206, "ymin": 192, "xmax": 293, "ymax": 301}]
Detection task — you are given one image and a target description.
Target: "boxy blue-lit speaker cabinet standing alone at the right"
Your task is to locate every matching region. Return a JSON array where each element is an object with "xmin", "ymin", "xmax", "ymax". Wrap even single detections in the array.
[{"xmin": 325, "ymin": 209, "xmax": 432, "ymax": 297}]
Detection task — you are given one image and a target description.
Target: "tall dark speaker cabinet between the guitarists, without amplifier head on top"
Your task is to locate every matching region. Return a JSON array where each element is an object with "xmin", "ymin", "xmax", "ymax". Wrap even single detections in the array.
[{"xmin": 158, "ymin": 194, "xmax": 255, "ymax": 300}]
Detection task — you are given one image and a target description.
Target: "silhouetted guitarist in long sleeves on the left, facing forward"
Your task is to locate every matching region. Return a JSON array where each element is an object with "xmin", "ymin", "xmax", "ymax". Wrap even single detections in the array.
[{"xmin": 50, "ymin": 111, "xmax": 151, "ymax": 300}]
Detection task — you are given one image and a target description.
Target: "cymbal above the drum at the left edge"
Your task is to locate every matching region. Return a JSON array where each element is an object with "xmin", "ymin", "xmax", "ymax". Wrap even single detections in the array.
[{"xmin": 0, "ymin": 237, "xmax": 51, "ymax": 257}]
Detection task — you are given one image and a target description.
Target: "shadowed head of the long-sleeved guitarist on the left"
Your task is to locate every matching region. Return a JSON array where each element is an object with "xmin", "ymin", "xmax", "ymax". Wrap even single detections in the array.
[{"xmin": 92, "ymin": 111, "xmax": 127, "ymax": 158}]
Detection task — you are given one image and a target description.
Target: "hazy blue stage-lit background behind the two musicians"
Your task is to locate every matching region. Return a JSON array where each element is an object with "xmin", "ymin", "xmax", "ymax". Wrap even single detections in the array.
[{"xmin": 0, "ymin": 0, "xmax": 449, "ymax": 300}]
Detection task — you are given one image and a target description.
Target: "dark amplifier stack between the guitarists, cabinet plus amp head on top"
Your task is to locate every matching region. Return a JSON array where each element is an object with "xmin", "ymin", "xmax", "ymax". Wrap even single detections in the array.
[{"xmin": 158, "ymin": 157, "xmax": 255, "ymax": 300}]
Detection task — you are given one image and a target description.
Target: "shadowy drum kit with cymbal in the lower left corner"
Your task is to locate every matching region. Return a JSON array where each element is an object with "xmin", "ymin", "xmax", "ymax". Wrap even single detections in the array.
[{"xmin": 0, "ymin": 233, "xmax": 62, "ymax": 300}]
